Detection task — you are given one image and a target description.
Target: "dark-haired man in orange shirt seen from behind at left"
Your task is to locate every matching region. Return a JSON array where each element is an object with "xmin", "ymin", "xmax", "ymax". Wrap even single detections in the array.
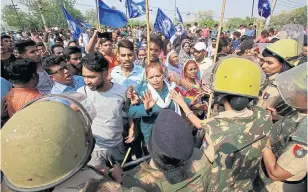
[{"xmin": 6, "ymin": 59, "xmax": 42, "ymax": 117}]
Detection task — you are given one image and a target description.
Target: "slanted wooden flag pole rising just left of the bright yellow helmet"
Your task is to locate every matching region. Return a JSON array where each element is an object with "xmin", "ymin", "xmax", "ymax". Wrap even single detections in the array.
[{"xmin": 206, "ymin": 0, "xmax": 226, "ymax": 118}]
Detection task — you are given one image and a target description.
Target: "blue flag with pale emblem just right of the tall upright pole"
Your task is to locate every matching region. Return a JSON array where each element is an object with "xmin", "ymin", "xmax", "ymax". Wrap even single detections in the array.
[{"xmin": 154, "ymin": 8, "xmax": 175, "ymax": 39}]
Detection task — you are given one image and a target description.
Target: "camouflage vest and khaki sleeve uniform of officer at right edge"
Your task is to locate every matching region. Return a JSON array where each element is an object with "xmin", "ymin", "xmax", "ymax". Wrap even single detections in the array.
[{"xmin": 254, "ymin": 112, "xmax": 307, "ymax": 192}]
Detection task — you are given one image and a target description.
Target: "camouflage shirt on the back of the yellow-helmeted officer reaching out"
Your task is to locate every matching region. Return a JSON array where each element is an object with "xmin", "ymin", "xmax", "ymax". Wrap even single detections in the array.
[{"xmin": 203, "ymin": 107, "xmax": 272, "ymax": 192}]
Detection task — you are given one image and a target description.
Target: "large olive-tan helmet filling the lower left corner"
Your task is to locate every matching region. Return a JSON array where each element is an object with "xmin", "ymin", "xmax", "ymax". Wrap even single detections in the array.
[{"xmin": 1, "ymin": 100, "xmax": 93, "ymax": 191}]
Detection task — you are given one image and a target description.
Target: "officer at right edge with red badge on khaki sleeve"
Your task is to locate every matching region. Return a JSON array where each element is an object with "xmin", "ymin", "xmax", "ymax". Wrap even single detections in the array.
[{"xmin": 263, "ymin": 63, "xmax": 308, "ymax": 192}]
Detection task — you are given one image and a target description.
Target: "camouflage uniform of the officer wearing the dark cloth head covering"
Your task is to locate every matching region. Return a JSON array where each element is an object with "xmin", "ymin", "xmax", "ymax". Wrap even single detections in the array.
[{"xmin": 123, "ymin": 149, "xmax": 211, "ymax": 192}]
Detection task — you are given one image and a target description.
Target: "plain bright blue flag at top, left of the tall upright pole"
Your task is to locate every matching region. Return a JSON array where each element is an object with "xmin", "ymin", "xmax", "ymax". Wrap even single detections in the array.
[{"xmin": 98, "ymin": 0, "xmax": 128, "ymax": 28}]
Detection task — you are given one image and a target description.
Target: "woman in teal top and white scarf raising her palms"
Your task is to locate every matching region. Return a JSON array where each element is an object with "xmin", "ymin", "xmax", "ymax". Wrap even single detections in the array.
[{"xmin": 128, "ymin": 62, "xmax": 192, "ymax": 144}]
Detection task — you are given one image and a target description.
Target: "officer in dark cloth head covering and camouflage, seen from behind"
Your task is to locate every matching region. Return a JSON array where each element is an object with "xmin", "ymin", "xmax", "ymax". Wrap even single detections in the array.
[{"xmin": 123, "ymin": 109, "xmax": 210, "ymax": 192}]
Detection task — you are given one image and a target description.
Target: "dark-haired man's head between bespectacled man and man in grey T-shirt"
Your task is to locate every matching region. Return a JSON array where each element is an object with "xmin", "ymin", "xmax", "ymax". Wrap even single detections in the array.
[{"xmin": 63, "ymin": 47, "xmax": 82, "ymax": 75}]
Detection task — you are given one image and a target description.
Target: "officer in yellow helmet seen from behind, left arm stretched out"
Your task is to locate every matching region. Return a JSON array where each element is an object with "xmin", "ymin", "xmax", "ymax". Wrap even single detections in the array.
[{"xmin": 172, "ymin": 57, "xmax": 272, "ymax": 191}]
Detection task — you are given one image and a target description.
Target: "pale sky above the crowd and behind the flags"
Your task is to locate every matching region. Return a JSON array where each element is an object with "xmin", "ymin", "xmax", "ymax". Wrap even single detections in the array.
[{"xmin": 1, "ymin": 0, "xmax": 307, "ymax": 22}]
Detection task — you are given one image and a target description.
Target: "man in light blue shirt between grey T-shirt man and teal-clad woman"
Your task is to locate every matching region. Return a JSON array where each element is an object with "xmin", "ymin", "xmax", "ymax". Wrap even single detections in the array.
[{"xmin": 110, "ymin": 40, "xmax": 144, "ymax": 89}]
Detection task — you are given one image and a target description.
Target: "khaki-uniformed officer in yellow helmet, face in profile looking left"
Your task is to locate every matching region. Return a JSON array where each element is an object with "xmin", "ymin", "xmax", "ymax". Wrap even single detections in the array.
[{"xmin": 257, "ymin": 39, "xmax": 299, "ymax": 116}]
